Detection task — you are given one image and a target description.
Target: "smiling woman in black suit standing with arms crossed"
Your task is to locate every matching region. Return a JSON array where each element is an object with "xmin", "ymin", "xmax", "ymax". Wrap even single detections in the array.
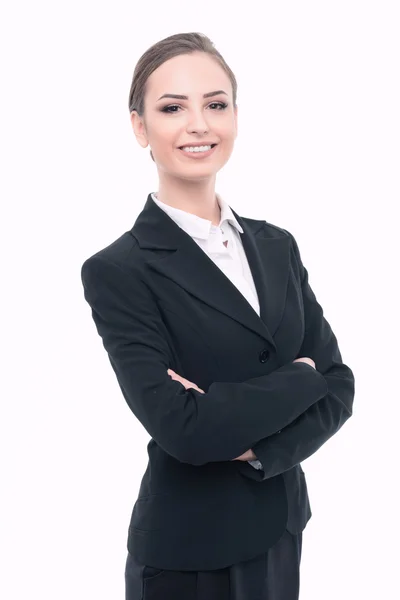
[{"xmin": 82, "ymin": 33, "xmax": 354, "ymax": 600}]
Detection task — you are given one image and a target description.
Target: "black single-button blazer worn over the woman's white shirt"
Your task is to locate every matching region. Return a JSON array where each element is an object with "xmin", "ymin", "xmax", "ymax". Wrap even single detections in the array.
[{"xmin": 81, "ymin": 194, "xmax": 354, "ymax": 570}]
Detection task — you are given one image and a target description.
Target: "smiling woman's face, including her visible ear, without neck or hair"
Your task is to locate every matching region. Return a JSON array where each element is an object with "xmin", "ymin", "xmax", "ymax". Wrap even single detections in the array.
[{"xmin": 131, "ymin": 52, "xmax": 237, "ymax": 180}]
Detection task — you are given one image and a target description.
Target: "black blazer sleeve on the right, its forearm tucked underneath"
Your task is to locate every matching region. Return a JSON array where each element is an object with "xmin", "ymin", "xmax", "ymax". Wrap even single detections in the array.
[{"xmin": 237, "ymin": 230, "xmax": 355, "ymax": 481}]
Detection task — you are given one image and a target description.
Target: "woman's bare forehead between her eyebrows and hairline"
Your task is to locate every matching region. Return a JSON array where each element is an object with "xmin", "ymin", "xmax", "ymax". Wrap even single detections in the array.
[{"xmin": 146, "ymin": 53, "xmax": 231, "ymax": 100}]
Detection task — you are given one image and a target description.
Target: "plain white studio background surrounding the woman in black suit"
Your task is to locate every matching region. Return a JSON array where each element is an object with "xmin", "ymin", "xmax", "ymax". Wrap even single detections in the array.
[{"xmin": 0, "ymin": 0, "xmax": 400, "ymax": 600}]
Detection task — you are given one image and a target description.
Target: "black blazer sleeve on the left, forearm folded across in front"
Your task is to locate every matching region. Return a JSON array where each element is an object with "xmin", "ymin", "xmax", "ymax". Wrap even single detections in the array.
[{"xmin": 81, "ymin": 254, "xmax": 327, "ymax": 468}]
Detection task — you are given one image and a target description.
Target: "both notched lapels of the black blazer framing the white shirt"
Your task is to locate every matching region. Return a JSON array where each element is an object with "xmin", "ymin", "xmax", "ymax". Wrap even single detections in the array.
[{"xmin": 130, "ymin": 194, "xmax": 290, "ymax": 349}]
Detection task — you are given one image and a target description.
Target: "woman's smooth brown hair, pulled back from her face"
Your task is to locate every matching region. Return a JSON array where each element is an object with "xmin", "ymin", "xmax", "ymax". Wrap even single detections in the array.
[{"xmin": 129, "ymin": 33, "xmax": 237, "ymax": 117}]
